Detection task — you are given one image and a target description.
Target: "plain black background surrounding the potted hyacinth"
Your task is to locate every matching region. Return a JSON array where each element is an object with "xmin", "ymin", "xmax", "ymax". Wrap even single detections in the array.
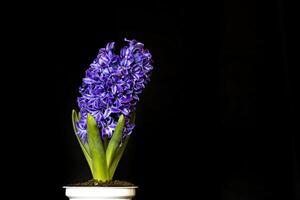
[{"xmin": 2, "ymin": 0, "xmax": 299, "ymax": 199}]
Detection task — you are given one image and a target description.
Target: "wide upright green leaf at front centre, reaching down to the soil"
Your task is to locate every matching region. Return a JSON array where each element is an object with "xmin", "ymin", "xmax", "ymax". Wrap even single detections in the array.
[{"xmin": 87, "ymin": 114, "xmax": 109, "ymax": 181}]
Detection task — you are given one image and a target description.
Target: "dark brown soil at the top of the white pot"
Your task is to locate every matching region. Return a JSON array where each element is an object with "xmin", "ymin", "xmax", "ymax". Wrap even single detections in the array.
[{"xmin": 69, "ymin": 179, "xmax": 135, "ymax": 187}]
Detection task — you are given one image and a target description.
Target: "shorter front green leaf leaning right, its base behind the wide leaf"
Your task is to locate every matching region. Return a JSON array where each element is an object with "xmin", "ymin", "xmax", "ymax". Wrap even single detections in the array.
[{"xmin": 106, "ymin": 115, "xmax": 125, "ymax": 168}]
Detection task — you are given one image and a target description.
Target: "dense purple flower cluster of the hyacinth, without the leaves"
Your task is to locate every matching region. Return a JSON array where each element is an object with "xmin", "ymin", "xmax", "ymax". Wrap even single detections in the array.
[{"xmin": 76, "ymin": 39, "xmax": 153, "ymax": 142}]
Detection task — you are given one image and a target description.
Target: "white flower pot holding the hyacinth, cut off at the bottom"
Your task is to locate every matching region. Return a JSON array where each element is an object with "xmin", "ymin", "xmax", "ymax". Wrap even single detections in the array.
[{"xmin": 64, "ymin": 186, "xmax": 137, "ymax": 200}]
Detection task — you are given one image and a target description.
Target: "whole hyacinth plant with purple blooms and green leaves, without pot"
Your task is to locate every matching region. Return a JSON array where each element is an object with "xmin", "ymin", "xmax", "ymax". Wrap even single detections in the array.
[{"xmin": 72, "ymin": 39, "xmax": 153, "ymax": 181}]
